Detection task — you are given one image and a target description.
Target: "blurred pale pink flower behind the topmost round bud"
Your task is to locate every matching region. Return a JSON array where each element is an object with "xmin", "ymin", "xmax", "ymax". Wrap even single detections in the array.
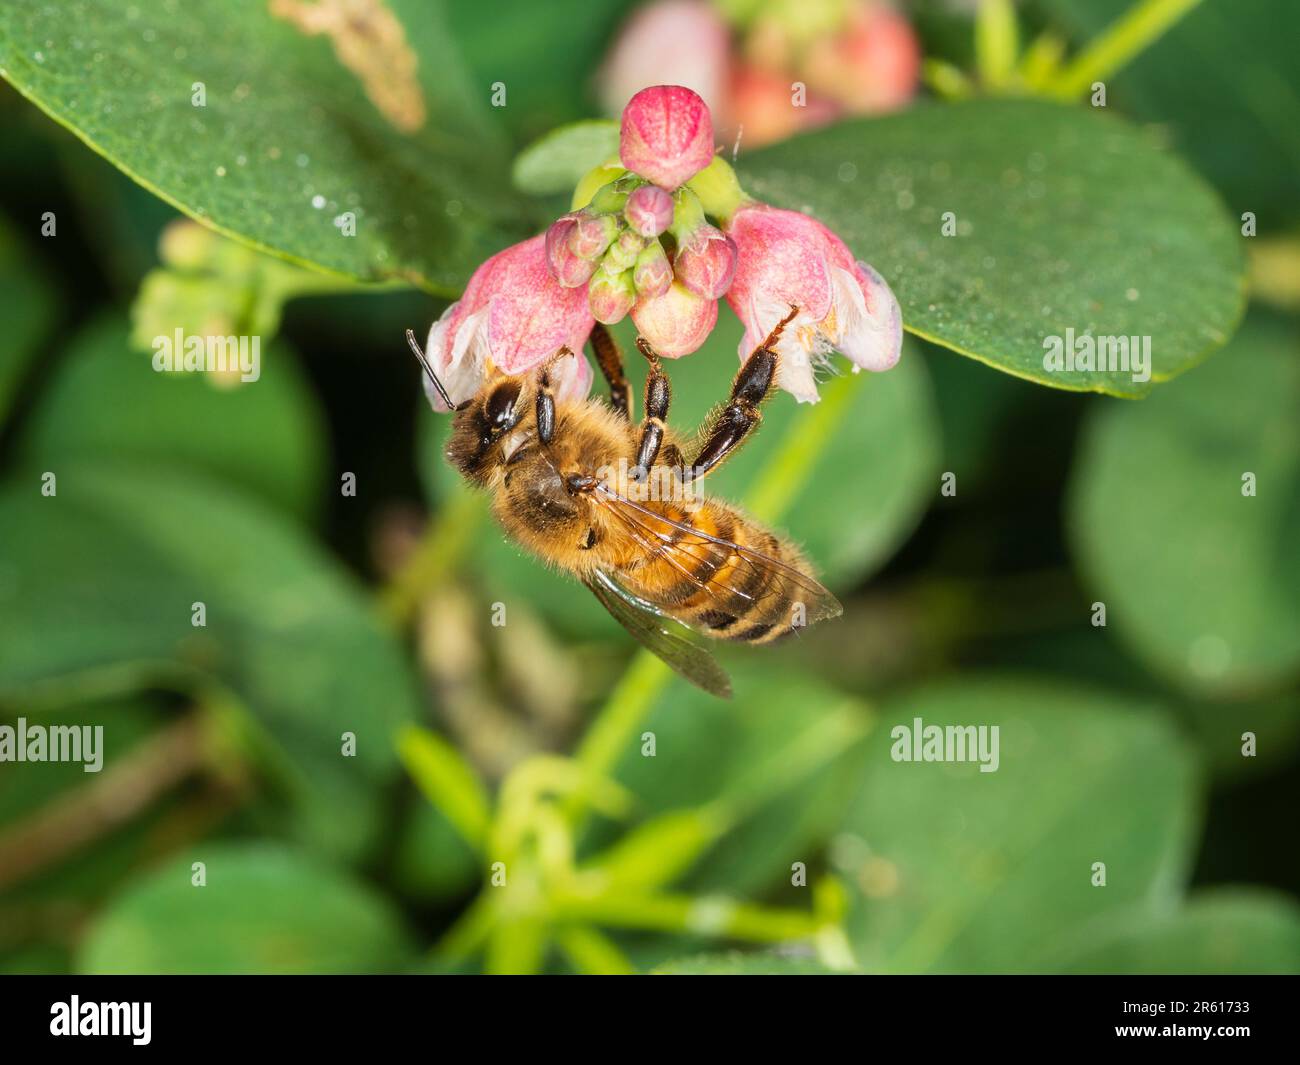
[{"xmin": 597, "ymin": 0, "xmax": 731, "ymax": 130}]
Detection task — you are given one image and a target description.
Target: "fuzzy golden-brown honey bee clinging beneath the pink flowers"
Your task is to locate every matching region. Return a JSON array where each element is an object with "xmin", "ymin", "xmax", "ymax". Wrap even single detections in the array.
[{"xmin": 407, "ymin": 308, "xmax": 842, "ymax": 698}]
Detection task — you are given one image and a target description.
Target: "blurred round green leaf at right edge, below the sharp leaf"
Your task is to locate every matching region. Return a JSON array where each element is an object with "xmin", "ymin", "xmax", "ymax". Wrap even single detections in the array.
[{"xmin": 1070, "ymin": 316, "xmax": 1300, "ymax": 693}]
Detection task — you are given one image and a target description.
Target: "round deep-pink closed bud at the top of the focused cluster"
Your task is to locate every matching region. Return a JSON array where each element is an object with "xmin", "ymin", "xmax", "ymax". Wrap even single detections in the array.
[{"xmin": 619, "ymin": 85, "xmax": 714, "ymax": 189}]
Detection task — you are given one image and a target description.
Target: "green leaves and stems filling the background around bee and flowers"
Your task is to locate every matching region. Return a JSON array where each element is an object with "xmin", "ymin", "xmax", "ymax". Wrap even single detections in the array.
[{"xmin": 0, "ymin": 0, "xmax": 1300, "ymax": 973}]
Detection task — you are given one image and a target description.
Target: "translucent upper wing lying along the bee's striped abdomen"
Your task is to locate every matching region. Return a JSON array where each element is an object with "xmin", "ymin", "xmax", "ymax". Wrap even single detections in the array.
[{"xmin": 598, "ymin": 485, "xmax": 844, "ymax": 625}]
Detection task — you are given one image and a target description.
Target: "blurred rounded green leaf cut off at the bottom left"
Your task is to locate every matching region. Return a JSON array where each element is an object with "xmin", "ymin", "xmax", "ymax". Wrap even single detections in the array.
[{"xmin": 77, "ymin": 843, "xmax": 413, "ymax": 974}]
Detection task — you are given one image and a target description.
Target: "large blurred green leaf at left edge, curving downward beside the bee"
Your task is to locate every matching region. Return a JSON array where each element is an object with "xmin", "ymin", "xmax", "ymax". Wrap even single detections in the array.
[{"xmin": 0, "ymin": 463, "xmax": 416, "ymax": 857}]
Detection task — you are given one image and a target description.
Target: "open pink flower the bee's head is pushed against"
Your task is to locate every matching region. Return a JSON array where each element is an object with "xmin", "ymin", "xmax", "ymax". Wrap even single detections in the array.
[{"xmin": 425, "ymin": 235, "xmax": 593, "ymax": 410}]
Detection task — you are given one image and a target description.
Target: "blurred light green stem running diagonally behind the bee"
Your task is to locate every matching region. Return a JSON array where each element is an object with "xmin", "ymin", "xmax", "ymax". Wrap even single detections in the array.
[{"xmin": 568, "ymin": 373, "xmax": 867, "ymax": 815}]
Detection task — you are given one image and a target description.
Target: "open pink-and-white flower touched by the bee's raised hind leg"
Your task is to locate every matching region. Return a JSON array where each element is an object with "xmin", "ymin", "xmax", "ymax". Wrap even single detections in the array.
[{"xmin": 728, "ymin": 203, "xmax": 902, "ymax": 403}]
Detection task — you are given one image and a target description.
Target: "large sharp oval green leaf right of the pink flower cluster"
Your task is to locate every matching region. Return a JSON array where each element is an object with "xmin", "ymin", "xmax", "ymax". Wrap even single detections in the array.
[{"xmin": 740, "ymin": 100, "xmax": 1244, "ymax": 395}]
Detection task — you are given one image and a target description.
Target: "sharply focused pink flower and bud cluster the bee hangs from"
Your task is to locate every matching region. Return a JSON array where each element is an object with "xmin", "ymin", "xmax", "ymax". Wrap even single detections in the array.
[{"xmin": 426, "ymin": 86, "xmax": 902, "ymax": 410}]
